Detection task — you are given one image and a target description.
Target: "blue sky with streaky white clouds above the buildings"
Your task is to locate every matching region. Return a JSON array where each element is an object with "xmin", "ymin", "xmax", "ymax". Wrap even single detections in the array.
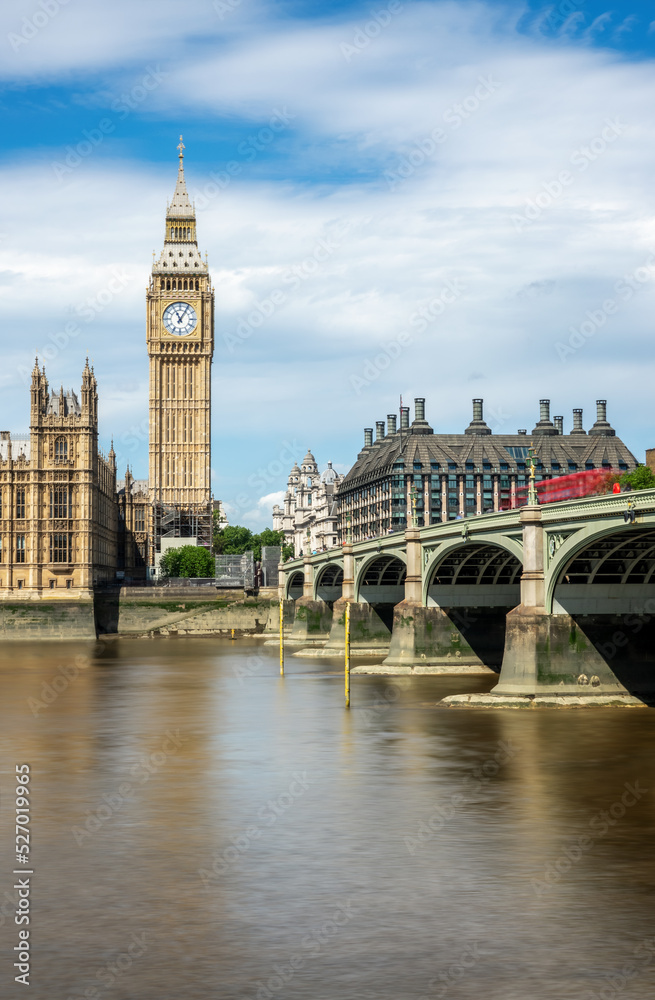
[{"xmin": 0, "ymin": 0, "xmax": 655, "ymax": 528}]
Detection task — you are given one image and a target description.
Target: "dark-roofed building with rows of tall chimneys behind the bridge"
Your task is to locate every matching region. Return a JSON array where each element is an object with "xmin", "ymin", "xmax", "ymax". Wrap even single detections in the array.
[{"xmin": 338, "ymin": 398, "xmax": 637, "ymax": 541}]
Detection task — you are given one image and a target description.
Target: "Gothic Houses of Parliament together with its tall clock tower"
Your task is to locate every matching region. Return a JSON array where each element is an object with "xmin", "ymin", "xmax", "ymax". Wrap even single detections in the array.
[{"xmin": 0, "ymin": 138, "xmax": 214, "ymax": 599}]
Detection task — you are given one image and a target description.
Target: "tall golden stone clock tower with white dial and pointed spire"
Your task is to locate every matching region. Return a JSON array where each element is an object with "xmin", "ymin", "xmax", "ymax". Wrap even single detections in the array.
[{"xmin": 146, "ymin": 136, "xmax": 214, "ymax": 558}]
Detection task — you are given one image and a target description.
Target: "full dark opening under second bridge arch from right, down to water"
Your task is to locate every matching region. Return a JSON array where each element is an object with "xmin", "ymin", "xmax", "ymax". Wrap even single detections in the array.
[{"xmin": 426, "ymin": 542, "xmax": 523, "ymax": 670}]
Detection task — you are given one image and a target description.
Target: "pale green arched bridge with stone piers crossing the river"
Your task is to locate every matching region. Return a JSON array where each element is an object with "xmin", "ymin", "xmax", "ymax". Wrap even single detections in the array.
[{"xmin": 280, "ymin": 490, "xmax": 655, "ymax": 704}]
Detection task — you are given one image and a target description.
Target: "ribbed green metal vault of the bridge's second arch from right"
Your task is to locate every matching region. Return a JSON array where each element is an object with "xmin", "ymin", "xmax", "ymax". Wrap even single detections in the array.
[{"xmin": 423, "ymin": 535, "xmax": 523, "ymax": 607}]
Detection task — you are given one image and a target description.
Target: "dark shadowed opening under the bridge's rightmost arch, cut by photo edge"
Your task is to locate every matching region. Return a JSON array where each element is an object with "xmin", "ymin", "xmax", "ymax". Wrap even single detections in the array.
[{"xmin": 553, "ymin": 526, "xmax": 655, "ymax": 700}]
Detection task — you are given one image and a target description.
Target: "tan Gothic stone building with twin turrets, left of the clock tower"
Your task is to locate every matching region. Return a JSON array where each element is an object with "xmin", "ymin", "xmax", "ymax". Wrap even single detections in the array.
[{"xmin": 0, "ymin": 361, "xmax": 117, "ymax": 599}]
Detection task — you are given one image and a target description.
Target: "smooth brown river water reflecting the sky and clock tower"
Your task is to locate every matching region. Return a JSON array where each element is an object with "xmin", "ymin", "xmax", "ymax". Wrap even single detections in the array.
[{"xmin": 0, "ymin": 639, "xmax": 655, "ymax": 1000}]
